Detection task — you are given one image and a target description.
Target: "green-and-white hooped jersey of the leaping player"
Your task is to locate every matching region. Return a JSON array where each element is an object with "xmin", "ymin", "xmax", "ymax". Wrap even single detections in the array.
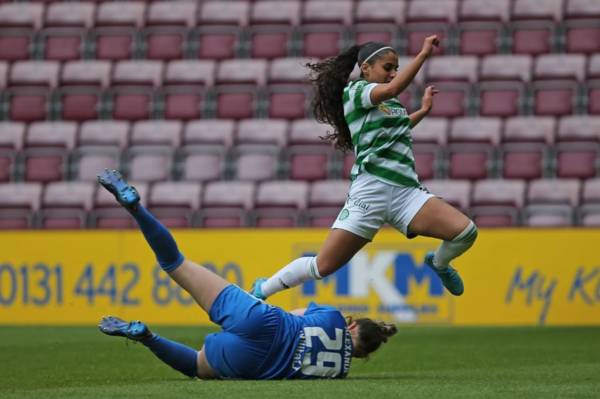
[{"xmin": 344, "ymin": 80, "xmax": 421, "ymax": 187}]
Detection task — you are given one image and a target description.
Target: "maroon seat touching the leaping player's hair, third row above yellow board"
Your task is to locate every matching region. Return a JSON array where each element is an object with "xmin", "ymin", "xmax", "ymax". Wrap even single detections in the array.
[{"xmin": 267, "ymin": 58, "xmax": 311, "ymax": 119}]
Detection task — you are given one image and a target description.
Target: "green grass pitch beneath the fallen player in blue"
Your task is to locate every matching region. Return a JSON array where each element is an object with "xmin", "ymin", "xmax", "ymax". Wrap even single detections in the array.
[{"xmin": 0, "ymin": 326, "xmax": 600, "ymax": 399}]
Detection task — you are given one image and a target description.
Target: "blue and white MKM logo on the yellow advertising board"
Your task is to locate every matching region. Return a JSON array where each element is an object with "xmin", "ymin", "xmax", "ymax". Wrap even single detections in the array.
[{"xmin": 302, "ymin": 250, "xmax": 451, "ymax": 322}]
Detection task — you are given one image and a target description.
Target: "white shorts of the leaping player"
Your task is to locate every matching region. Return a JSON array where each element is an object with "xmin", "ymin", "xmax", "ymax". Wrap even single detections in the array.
[{"xmin": 331, "ymin": 172, "xmax": 434, "ymax": 240}]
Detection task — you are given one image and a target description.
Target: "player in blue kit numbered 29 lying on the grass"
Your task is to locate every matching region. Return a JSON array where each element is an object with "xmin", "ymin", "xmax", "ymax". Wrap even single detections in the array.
[{"xmin": 98, "ymin": 170, "xmax": 396, "ymax": 380}]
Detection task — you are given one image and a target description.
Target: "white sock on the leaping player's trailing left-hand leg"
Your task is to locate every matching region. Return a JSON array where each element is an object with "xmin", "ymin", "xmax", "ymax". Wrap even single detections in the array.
[{"xmin": 261, "ymin": 256, "xmax": 322, "ymax": 297}]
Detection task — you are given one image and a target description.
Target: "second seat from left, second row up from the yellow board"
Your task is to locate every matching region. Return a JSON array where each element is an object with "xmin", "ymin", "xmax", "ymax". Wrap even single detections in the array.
[{"xmin": 23, "ymin": 122, "xmax": 77, "ymax": 183}]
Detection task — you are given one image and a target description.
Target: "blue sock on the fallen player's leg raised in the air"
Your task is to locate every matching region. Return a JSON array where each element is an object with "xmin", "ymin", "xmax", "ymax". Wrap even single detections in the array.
[{"xmin": 129, "ymin": 204, "xmax": 184, "ymax": 272}]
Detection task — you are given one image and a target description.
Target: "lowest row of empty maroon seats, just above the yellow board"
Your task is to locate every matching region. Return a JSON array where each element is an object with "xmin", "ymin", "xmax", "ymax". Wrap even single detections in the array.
[{"xmin": 0, "ymin": 179, "xmax": 600, "ymax": 229}]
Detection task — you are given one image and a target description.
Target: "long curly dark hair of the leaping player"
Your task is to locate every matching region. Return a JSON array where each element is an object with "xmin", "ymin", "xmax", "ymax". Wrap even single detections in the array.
[{"xmin": 306, "ymin": 42, "xmax": 393, "ymax": 152}]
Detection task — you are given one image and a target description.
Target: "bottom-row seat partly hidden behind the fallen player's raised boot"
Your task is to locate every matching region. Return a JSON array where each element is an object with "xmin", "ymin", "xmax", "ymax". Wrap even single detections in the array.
[{"xmin": 90, "ymin": 180, "xmax": 148, "ymax": 229}]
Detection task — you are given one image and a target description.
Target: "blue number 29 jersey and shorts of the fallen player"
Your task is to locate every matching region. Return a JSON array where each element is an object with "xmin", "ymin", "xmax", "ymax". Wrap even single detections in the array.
[{"xmin": 204, "ymin": 285, "xmax": 352, "ymax": 380}]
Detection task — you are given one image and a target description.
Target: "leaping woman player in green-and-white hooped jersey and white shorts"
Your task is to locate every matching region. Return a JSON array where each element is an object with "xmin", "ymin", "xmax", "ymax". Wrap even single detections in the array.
[{"xmin": 251, "ymin": 35, "xmax": 477, "ymax": 299}]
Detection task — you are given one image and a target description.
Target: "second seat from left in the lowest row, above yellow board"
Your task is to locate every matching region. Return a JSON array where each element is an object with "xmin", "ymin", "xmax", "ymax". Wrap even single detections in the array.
[{"xmin": 39, "ymin": 182, "xmax": 96, "ymax": 229}]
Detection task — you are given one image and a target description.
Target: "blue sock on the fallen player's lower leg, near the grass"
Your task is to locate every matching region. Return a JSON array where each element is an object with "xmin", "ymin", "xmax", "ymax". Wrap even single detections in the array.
[{"xmin": 140, "ymin": 334, "xmax": 198, "ymax": 377}]
